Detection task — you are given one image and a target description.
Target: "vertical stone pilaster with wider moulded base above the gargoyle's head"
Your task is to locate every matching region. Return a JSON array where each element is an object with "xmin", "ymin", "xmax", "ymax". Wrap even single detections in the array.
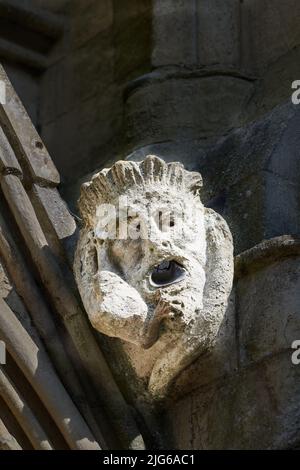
[{"xmin": 125, "ymin": 0, "xmax": 253, "ymax": 158}]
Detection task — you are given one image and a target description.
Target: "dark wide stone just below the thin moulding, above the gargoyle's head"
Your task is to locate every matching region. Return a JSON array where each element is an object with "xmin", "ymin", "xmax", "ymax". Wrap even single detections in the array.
[{"xmin": 126, "ymin": 75, "xmax": 252, "ymax": 147}]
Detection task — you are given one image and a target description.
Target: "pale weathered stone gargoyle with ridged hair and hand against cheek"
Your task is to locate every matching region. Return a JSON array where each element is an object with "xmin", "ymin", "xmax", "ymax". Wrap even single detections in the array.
[{"xmin": 74, "ymin": 155, "xmax": 233, "ymax": 397}]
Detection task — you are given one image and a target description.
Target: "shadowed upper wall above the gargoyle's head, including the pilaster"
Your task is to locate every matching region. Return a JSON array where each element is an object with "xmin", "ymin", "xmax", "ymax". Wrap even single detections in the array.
[{"xmin": 6, "ymin": 0, "xmax": 300, "ymax": 211}]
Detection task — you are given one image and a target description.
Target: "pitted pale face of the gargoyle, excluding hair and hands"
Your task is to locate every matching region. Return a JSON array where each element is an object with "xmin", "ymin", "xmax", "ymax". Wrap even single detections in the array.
[{"xmin": 109, "ymin": 185, "xmax": 206, "ymax": 347}]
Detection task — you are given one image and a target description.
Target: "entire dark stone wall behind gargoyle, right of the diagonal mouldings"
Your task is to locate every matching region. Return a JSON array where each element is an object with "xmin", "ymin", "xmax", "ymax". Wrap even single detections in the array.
[{"xmin": 1, "ymin": 0, "xmax": 300, "ymax": 449}]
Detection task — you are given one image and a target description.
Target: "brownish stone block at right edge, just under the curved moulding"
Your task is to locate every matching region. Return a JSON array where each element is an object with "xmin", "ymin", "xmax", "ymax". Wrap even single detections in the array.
[{"xmin": 237, "ymin": 257, "xmax": 300, "ymax": 365}]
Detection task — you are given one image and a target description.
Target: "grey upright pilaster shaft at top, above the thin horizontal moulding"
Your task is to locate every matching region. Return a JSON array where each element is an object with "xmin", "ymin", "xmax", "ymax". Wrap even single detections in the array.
[{"xmin": 152, "ymin": 0, "xmax": 240, "ymax": 67}]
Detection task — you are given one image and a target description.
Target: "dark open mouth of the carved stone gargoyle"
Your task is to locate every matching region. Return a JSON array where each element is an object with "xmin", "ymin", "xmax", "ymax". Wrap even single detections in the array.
[{"xmin": 150, "ymin": 261, "xmax": 186, "ymax": 287}]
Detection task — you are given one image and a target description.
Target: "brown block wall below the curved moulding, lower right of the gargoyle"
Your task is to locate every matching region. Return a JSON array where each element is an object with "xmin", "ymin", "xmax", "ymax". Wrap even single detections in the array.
[{"xmin": 165, "ymin": 237, "xmax": 300, "ymax": 449}]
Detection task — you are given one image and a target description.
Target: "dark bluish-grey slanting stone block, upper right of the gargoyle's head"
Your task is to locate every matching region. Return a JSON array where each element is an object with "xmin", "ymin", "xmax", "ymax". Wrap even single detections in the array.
[{"xmin": 199, "ymin": 103, "xmax": 297, "ymax": 194}]
